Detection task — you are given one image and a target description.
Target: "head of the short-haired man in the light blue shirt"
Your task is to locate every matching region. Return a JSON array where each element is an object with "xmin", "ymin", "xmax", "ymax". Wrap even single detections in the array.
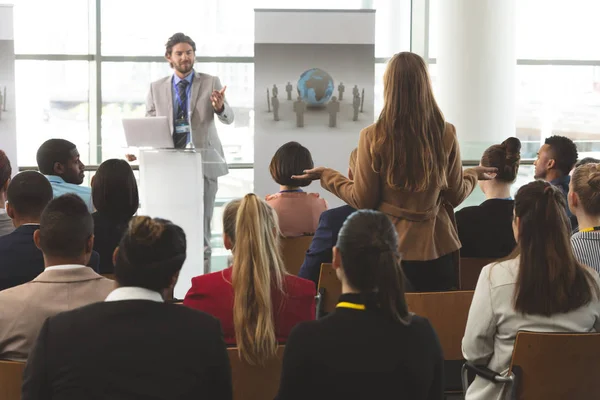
[{"xmin": 36, "ymin": 139, "xmax": 85, "ymax": 185}]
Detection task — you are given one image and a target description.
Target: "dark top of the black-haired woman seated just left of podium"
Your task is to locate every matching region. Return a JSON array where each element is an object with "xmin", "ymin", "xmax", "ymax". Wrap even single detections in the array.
[{"xmin": 92, "ymin": 211, "xmax": 129, "ymax": 274}]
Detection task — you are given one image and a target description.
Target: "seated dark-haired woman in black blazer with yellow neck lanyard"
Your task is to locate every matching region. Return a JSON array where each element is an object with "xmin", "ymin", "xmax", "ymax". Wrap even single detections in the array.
[{"xmin": 276, "ymin": 210, "xmax": 444, "ymax": 400}]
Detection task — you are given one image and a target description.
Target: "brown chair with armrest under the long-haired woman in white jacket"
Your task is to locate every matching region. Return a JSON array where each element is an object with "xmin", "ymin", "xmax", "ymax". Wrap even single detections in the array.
[{"xmin": 463, "ymin": 332, "xmax": 600, "ymax": 400}]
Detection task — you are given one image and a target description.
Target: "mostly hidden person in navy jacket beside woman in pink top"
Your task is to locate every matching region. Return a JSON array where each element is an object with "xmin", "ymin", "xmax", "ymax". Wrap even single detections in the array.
[{"xmin": 298, "ymin": 149, "xmax": 358, "ymax": 286}]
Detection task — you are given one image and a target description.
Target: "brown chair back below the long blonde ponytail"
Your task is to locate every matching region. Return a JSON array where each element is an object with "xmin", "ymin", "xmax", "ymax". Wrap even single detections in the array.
[{"xmin": 227, "ymin": 346, "xmax": 285, "ymax": 400}]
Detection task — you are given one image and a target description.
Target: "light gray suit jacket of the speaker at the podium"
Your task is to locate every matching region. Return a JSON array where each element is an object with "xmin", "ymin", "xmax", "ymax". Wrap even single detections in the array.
[{"xmin": 146, "ymin": 72, "xmax": 234, "ymax": 180}]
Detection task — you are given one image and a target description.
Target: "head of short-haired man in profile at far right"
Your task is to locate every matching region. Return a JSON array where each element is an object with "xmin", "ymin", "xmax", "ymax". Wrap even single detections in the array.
[{"xmin": 533, "ymin": 136, "xmax": 577, "ymax": 181}]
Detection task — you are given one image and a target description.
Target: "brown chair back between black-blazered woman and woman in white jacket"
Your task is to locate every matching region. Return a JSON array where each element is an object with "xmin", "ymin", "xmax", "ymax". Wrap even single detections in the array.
[{"xmin": 406, "ymin": 291, "xmax": 473, "ymax": 360}]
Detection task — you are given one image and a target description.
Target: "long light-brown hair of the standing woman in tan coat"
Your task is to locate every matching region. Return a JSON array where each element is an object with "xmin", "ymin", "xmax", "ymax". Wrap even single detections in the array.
[{"xmin": 376, "ymin": 52, "xmax": 448, "ymax": 192}]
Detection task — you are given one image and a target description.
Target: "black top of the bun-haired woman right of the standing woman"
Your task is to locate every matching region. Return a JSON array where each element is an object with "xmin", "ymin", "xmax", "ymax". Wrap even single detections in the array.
[{"xmin": 456, "ymin": 199, "xmax": 517, "ymax": 258}]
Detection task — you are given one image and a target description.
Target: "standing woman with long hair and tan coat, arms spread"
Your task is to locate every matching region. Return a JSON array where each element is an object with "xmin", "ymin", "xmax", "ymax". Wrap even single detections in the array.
[{"xmin": 297, "ymin": 53, "xmax": 496, "ymax": 291}]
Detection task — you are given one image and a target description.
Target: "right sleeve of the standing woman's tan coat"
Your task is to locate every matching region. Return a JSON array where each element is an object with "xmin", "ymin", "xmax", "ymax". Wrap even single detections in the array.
[{"xmin": 443, "ymin": 124, "xmax": 477, "ymax": 207}]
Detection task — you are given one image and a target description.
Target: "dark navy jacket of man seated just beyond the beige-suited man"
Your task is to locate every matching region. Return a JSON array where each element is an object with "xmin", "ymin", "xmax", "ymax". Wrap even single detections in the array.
[{"xmin": 0, "ymin": 225, "xmax": 100, "ymax": 290}]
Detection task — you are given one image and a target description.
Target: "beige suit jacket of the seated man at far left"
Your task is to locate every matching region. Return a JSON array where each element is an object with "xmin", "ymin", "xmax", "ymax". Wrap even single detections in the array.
[{"xmin": 0, "ymin": 267, "xmax": 115, "ymax": 361}]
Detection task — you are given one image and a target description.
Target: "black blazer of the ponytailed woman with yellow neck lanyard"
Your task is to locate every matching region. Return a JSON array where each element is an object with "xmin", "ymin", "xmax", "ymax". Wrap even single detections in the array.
[{"xmin": 277, "ymin": 294, "xmax": 444, "ymax": 400}]
